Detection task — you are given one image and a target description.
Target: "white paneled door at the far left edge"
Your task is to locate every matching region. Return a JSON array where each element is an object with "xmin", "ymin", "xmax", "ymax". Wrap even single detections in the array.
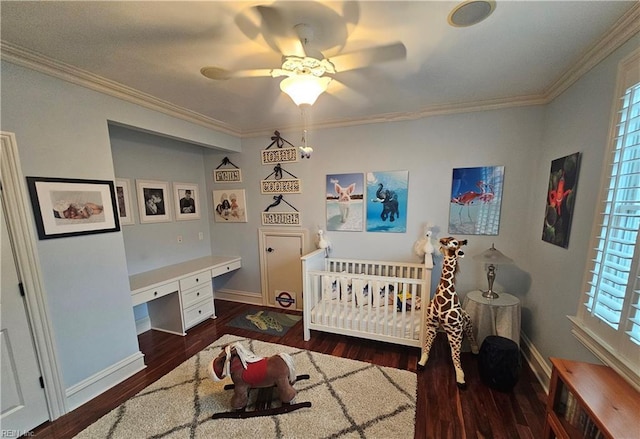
[{"xmin": 0, "ymin": 191, "xmax": 49, "ymax": 436}]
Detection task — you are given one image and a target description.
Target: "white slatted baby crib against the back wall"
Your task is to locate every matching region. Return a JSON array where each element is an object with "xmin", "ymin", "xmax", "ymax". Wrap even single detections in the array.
[{"xmin": 301, "ymin": 249, "xmax": 432, "ymax": 347}]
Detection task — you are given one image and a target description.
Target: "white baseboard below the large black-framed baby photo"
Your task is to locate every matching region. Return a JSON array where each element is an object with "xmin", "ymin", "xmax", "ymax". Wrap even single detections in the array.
[{"xmin": 65, "ymin": 351, "xmax": 147, "ymax": 411}]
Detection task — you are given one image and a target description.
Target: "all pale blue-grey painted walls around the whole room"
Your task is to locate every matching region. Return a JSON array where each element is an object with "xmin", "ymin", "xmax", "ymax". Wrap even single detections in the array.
[{"xmin": 1, "ymin": 29, "xmax": 640, "ymax": 398}]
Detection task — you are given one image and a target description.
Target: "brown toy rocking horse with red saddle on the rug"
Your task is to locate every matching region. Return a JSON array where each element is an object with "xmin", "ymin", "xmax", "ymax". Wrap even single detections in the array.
[{"xmin": 209, "ymin": 342, "xmax": 311, "ymax": 419}]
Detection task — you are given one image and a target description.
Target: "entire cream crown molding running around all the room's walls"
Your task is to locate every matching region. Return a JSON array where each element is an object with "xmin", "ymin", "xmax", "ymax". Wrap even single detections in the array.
[{"xmin": 0, "ymin": 3, "xmax": 640, "ymax": 138}]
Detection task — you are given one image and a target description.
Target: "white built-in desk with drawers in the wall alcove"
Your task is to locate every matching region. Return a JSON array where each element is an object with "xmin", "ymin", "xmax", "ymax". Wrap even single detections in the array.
[{"xmin": 129, "ymin": 256, "xmax": 242, "ymax": 335}]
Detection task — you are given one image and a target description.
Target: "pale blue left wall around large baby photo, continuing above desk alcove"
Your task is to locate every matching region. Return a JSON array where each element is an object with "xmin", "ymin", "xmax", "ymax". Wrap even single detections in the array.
[{"xmin": 0, "ymin": 61, "xmax": 240, "ymax": 388}]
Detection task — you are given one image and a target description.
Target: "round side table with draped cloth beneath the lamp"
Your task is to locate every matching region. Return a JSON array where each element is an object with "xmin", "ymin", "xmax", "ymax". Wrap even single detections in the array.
[{"xmin": 462, "ymin": 290, "xmax": 520, "ymax": 347}]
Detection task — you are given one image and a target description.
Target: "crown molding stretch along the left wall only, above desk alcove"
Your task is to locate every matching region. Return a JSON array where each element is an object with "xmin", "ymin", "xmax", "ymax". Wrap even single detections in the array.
[{"xmin": 0, "ymin": 40, "xmax": 241, "ymax": 137}]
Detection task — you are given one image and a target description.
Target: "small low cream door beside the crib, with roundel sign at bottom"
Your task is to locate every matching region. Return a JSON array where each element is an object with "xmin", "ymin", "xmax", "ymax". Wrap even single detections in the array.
[{"xmin": 261, "ymin": 232, "xmax": 304, "ymax": 310}]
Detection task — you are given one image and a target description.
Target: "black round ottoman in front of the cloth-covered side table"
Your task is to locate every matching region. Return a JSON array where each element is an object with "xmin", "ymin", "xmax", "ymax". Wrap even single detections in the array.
[{"xmin": 478, "ymin": 335, "xmax": 522, "ymax": 392}]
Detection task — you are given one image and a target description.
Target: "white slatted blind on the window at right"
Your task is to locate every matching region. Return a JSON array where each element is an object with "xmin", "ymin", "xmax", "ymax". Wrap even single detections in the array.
[{"xmin": 584, "ymin": 83, "xmax": 640, "ymax": 345}]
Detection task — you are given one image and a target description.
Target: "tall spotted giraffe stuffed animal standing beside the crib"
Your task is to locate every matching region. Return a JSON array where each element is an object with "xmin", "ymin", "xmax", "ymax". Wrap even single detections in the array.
[{"xmin": 418, "ymin": 237, "xmax": 478, "ymax": 389}]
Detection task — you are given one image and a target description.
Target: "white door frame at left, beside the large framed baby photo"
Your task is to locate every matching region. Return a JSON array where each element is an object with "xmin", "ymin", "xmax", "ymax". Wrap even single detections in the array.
[{"xmin": 0, "ymin": 131, "xmax": 67, "ymax": 420}]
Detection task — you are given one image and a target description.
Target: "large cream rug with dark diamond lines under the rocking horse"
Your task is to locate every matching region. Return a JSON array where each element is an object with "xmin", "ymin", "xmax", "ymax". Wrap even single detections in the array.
[{"xmin": 76, "ymin": 335, "xmax": 417, "ymax": 439}]
